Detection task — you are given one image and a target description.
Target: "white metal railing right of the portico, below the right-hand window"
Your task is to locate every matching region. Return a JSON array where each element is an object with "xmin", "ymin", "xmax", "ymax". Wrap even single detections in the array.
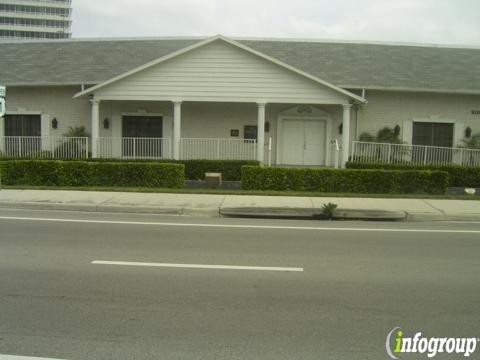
[{"xmin": 351, "ymin": 141, "xmax": 480, "ymax": 166}]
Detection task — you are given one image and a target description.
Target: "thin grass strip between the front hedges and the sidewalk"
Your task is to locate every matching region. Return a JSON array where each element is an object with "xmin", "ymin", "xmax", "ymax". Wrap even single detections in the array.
[{"xmin": 2, "ymin": 186, "xmax": 480, "ymax": 201}]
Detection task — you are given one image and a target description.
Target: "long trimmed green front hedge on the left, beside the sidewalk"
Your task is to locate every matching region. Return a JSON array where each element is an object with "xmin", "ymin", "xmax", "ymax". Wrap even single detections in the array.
[{"xmin": 0, "ymin": 160, "xmax": 185, "ymax": 188}]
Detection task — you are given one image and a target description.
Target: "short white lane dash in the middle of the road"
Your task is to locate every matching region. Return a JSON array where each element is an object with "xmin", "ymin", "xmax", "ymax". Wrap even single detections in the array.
[{"xmin": 92, "ymin": 260, "xmax": 304, "ymax": 272}]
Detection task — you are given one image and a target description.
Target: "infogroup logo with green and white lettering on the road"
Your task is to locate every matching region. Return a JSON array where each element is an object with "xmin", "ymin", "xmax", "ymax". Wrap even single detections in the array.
[{"xmin": 385, "ymin": 327, "xmax": 480, "ymax": 360}]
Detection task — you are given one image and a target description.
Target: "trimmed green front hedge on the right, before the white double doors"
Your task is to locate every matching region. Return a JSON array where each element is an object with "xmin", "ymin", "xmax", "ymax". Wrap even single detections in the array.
[{"xmin": 242, "ymin": 166, "xmax": 448, "ymax": 195}]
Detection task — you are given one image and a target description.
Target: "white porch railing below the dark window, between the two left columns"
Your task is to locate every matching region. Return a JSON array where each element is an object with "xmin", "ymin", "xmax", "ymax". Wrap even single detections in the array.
[{"xmin": 97, "ymin": 137, "xmax": 171, "ymax": 159}]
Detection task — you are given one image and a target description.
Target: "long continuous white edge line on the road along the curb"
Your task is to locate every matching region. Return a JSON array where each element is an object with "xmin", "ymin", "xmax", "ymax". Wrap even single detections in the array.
[{"xmin": 0, "ymin": 216, "xmax": 480, "ymax": 234}]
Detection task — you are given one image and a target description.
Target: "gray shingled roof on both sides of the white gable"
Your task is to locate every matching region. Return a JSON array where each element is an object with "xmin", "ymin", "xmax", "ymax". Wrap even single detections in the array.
[{"xmin": 0, "ymin": 38, "xmax": 480, "ymax": 93}]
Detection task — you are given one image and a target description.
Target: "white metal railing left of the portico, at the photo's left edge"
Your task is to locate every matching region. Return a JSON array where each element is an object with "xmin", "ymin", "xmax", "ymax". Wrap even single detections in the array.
[{"xmin": 0, "ymin": 136, "xmax": 89, "ymax": 159}]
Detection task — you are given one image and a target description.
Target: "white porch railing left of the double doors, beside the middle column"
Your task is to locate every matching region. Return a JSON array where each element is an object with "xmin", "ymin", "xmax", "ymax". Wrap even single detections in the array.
[{"xmin": 180, "ymin": 138, "xmax": 257, "ymax": 160}]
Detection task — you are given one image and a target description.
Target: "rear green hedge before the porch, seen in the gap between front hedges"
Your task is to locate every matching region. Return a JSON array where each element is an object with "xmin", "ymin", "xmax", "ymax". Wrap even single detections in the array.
[{"xmin": 0, "ymin": 159, "xmax": 259, "ymax": 181}]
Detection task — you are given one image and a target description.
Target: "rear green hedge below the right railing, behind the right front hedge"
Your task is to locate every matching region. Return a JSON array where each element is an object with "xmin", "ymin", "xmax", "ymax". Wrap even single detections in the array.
[{"xmin": 347, "ymin": 162, "xmax": 480, "ymax": 187}]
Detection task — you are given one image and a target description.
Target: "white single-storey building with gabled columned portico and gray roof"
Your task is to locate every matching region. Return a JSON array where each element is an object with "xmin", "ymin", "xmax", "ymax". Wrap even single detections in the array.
[{"xmin": 0, "ymin": 36, "xmax": 480, "ymax": 166}]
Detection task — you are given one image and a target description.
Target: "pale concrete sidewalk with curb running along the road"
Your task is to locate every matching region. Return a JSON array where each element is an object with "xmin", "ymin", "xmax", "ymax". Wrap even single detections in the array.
[{"xmin": 0, "ymin": 190, "xmax": 480, "ymax": 221}]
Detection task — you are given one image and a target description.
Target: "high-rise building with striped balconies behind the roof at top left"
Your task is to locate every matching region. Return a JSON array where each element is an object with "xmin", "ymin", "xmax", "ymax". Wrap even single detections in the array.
[{"xmin": 0, "ymin": 0, "xmax": 72, "ymax": 40}]
